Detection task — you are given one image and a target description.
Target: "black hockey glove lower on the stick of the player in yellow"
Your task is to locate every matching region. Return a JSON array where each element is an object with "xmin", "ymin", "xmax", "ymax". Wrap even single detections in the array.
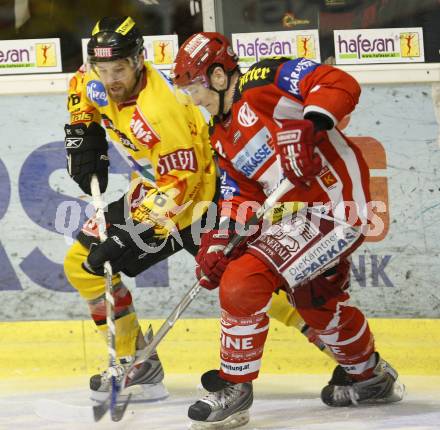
[{"xmin": 83, "ymin": 222, "xmax": 158, "ymax": 276}]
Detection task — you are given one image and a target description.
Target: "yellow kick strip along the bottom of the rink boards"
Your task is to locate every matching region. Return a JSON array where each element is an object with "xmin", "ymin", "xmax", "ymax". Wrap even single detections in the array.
[{"xmin": 0, "ymin": 319, "xmax": 440, "ymax": 379}]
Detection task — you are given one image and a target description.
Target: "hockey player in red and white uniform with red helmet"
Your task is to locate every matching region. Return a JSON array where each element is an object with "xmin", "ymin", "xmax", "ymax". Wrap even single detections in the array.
[{"xmin": 172, "ymin": 33, "xmax": 403, "ymax": 428}]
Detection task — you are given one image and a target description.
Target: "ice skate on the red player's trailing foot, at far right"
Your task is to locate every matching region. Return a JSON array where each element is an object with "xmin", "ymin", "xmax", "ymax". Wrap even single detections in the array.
[{"xmin": 321, "ymin": 353, "xmax": 405, "ymax": 406}]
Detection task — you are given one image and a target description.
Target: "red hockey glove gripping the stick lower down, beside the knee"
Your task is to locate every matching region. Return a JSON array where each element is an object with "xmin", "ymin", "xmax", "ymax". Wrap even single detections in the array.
[{"xmin": 196, "ymin": 230, "xmax": 246, "ymax": 290}]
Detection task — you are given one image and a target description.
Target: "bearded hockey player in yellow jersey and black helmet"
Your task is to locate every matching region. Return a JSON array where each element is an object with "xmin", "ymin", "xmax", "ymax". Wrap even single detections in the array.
[{"xmin": 64, "ymin": 17, "xmax": 330, "ymax": 400}]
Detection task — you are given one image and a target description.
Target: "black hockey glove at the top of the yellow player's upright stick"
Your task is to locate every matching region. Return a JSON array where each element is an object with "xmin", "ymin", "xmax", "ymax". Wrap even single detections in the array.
[{"xmin": 64, "ymin": 122, "xmax": 109, "ymax": 195}]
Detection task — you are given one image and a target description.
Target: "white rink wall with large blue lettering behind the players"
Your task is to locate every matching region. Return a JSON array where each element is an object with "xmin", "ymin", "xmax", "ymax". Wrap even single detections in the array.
[{"xmin": 0, "ymin": 83, "xmax": 440, "ymax": 321}]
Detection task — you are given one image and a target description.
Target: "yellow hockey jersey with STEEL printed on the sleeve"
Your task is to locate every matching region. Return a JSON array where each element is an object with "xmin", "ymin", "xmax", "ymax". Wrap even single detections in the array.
[{"xmin": 68, "ymin": 62, "xmax": 216, "ymax": 235}]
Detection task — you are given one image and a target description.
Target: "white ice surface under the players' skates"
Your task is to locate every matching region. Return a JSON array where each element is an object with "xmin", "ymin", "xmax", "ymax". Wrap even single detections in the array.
[{"xmin": 0, "ymin": 374, "xmax": 440, "ymax": 430}]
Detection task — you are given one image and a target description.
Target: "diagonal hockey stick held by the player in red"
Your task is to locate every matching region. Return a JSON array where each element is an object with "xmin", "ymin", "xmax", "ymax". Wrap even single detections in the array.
[{"xmin": 98, "ymin": 179, "xmax": 294, "ymax": 421}]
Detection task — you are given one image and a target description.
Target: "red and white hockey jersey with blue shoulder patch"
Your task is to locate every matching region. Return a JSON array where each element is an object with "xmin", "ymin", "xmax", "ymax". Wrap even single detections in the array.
[{"xmin": 211, "ymin": 58, "xmax": 370, "ymax": 225}]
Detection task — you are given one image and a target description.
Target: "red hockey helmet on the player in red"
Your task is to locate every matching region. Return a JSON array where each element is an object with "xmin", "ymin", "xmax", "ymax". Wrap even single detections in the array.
[{"xmin": 171, "ymin": 32, "xmax": 238, "ymax": 86}]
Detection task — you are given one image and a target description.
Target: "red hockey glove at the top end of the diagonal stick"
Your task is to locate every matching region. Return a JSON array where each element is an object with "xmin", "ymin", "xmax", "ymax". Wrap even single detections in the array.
[{"xmin": 276, "ymin": 119, "xmax": 322, "ymax": 186}]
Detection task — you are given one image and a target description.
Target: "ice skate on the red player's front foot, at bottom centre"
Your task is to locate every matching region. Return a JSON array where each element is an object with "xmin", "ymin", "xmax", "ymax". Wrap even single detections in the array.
[{"xmin": 188, "ymin": 370, "xmax": 253, "ymax": 430}]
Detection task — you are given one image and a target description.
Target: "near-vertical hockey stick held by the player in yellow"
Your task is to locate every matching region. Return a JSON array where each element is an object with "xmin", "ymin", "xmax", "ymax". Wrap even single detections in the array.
[{"xmin": 90, "ymin": 175, "xmax": 128, "ymax": 421}]
